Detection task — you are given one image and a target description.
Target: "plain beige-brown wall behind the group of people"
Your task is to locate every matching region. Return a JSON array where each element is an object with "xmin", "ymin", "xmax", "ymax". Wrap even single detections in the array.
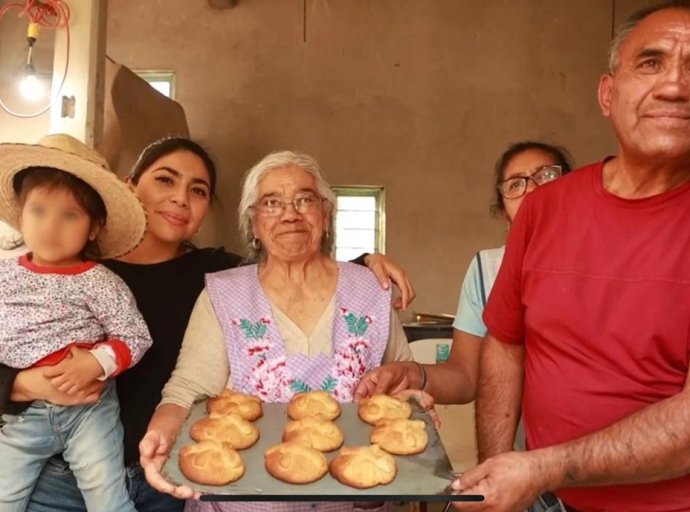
[{"xmin": 0, "ymin": 0, "xmax": 646, "ymax": 312}]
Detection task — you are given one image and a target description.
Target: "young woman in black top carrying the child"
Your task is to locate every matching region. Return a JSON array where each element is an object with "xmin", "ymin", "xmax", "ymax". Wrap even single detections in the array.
[{"xmin": 0, "ymin": 138, "xmax": 414, "ymax": 512}]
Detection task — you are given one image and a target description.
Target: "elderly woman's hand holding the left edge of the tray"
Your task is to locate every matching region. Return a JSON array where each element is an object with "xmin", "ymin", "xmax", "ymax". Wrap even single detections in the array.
[{"xmin": 139, "ymin": 429, "xmax": 196, "ymax": 500}]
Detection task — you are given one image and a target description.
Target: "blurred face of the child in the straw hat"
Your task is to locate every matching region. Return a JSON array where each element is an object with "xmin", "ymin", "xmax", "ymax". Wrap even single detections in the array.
[{"xmin": 20, "ymin": 187, "xmax": 96, "ymax": 267}]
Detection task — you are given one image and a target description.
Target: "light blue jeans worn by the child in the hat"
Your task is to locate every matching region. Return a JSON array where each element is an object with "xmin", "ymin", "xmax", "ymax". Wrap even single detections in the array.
[{"xmin": 0, "ymin": 381, "xmax": 135, "ymax": 512}]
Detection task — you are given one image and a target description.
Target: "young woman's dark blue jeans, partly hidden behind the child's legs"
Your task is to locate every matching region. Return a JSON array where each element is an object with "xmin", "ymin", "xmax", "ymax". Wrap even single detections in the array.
[{"xmin": 27, "ymin": 457, "xmax": 184, "ymax": 512}]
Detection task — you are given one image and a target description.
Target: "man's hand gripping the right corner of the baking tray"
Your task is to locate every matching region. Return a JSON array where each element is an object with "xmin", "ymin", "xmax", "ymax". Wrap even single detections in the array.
[{"xmin": 452, "ymin": 451, "xmax": 552, "ymax": 512}]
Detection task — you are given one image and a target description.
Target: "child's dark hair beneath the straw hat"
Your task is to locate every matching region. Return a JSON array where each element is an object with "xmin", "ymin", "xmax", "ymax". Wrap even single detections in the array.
[{"xmin": 12, "ymin": 167, "xmax": 108, "ymax": 260}]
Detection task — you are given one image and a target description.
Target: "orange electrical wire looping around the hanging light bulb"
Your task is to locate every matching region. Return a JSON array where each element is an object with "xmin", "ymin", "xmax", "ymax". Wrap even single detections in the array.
[{"xmin": 0, "ymin": 0, "xmax": 70, "ymax": 119}]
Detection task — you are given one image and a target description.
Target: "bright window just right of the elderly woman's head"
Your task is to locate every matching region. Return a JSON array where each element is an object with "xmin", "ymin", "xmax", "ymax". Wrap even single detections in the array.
[{"xmin": 333, "ymin": 187, "xmax": 385, "ymax": 261}]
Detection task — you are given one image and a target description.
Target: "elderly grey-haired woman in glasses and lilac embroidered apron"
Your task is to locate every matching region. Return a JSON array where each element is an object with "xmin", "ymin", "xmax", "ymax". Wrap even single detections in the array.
[{"xmin": 140, "ymin": 151, "xmax": 412, "ymax": 511}]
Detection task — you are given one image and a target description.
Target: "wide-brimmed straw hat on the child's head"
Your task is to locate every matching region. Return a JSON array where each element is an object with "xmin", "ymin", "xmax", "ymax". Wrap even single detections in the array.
[{"xmin": 0, "ymin": 134, "xmax": 146, "ymax": 259}]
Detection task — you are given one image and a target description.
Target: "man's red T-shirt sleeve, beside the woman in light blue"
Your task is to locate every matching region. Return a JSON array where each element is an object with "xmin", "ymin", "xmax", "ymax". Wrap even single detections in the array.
[{"xmin": 482, "ymin": 197, "xmax": 531, "ymax": 345}]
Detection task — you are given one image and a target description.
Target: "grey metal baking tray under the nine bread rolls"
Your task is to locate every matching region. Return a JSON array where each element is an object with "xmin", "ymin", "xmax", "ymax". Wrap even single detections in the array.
[{"xmin": 163, "ymin": 401, "xmax": 481, "ymax": 501}]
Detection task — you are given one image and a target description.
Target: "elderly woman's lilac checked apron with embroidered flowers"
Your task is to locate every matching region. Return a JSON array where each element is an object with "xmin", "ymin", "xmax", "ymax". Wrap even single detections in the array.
[{"xmin": 185, "ymin": 263, "xmax": 391, "ymax": 512}]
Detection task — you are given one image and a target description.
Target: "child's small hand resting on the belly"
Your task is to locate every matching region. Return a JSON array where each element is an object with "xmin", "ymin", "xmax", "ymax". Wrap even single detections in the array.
[{"xmin": 43, "ymin": 347, "xmax": 103, "ymax": 395}]
